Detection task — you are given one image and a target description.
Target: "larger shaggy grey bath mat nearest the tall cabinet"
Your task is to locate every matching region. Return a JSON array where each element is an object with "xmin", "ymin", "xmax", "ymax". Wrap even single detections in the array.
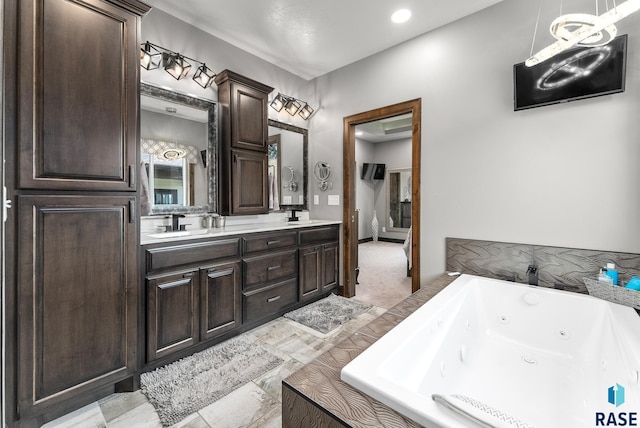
[{"xmin": 140, "ymin": 336, "xmax": 284, "ymax": 426}]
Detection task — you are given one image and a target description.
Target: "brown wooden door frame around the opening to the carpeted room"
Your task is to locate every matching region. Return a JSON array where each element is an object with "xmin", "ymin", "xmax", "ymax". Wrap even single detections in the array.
[{"xmin": 342, "ymin": 98, "xmax": 422, "ymax": 297}]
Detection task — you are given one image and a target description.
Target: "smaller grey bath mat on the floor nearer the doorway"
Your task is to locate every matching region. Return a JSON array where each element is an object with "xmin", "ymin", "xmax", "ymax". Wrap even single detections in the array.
[{"xmin": 284, "ymin": 294, "xmax": 371, "ymax": 333}]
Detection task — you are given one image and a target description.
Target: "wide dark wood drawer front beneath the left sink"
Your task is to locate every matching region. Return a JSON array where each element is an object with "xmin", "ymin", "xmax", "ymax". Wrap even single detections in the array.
[{"xmin": 145, "ymin": 238, "xmax": 240, "ymax": 272}]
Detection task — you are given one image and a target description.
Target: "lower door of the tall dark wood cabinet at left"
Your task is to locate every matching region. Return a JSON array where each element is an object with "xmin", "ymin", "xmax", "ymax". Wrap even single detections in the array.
[{"xmin": 17, "ymin": 196, "xmax": 139, "ymax": 417}]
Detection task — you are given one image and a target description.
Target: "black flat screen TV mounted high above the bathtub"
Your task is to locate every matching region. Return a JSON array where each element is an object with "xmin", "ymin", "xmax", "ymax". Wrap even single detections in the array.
[{"xmin": 513, "ymin": 34, "xmax": 627, "ymax": 110}]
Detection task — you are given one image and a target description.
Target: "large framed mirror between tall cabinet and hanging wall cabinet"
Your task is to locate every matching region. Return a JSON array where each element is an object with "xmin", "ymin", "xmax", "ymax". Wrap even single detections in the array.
[{"xmin": 140, "ymin": 83, "xmax": 218, "ymax": 215}]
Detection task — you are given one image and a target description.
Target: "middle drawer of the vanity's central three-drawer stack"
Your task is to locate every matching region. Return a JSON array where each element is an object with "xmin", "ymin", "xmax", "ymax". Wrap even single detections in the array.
[{"xmin": 242, "ymin": 249, "xmax": 298, "ymax": 290}]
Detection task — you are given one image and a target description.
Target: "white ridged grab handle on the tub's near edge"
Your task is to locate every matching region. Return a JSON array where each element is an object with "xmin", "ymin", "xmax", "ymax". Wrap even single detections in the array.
[{"xmin": 431, "ymin": 394, "xmax": 534, "ymax": 428}]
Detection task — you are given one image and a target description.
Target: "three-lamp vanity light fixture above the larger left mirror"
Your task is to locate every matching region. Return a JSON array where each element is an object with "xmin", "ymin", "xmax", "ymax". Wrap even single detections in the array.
[{"xmin": 140, "ymin": 41, "xmax": 216, "ymax": 89}]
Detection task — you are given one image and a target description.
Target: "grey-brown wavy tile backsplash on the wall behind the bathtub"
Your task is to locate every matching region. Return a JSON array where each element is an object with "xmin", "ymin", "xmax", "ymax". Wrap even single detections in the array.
[{"xmin": 446, "ymin": 238, "xmax": 640, "ymax": 294}]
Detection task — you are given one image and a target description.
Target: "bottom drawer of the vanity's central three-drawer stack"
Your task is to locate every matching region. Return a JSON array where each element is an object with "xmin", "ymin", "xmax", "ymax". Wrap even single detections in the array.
[{"xmin": 242, "ymin": 279, "xmax": 298, "ymax": 322}]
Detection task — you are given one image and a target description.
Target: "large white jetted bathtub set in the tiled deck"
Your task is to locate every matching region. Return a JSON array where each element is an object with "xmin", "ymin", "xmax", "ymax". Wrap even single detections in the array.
[{"xmin": 341, "ymin": 275, "xmax": 640, "ymax": 428}]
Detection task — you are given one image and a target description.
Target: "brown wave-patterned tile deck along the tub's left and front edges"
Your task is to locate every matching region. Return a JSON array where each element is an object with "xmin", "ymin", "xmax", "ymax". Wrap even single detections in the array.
[{"xmin": 282, "ymin": 275, "xmax": 456, "ymax": 428}]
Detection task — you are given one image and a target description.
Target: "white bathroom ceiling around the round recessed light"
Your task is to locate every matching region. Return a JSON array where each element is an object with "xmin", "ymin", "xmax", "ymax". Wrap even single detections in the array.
[{"xmin": 148, "ymin": 0, "xmax": 502, "ymax": 80}]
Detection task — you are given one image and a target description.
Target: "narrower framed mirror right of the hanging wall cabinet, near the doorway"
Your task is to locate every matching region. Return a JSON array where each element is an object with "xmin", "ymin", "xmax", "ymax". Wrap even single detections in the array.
[{"xmin": 268, "ymin": 119, "xmax": 309, "ymax": 211}]
